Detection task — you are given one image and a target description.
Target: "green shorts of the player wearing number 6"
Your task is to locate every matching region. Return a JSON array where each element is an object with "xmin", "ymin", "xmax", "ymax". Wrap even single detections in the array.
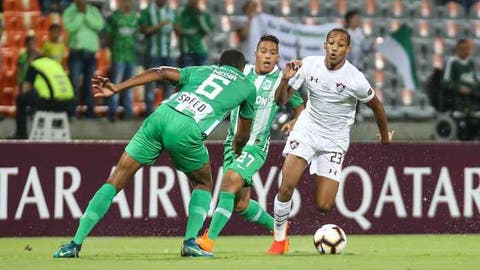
[{"xmin": 125, "ymin": 104, "xmax": 209, "ymax": 172}]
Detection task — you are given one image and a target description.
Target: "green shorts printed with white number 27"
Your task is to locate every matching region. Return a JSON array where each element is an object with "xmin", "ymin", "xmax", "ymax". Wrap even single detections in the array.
[{"xmin": 223, "ymin": 145, "xmax": 266, "ymax": 186}]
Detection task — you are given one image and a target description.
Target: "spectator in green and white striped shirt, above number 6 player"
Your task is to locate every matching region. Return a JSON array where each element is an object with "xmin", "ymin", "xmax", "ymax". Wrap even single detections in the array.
[{"xmin": 140, "ymin": 0, "xmax": 175, "ymax": 115}]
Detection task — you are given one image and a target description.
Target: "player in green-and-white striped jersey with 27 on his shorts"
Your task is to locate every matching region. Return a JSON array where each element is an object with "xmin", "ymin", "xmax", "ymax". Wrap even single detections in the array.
[{"xmin": 197, "ymin": 35, "xmax": 304, "ymax": 252}]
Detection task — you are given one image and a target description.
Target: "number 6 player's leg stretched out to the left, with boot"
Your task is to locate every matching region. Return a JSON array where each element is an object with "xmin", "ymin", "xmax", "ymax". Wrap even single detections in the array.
[{"xmin": 53, "ymin": 152, "xmax": 142, "ymax": 258}]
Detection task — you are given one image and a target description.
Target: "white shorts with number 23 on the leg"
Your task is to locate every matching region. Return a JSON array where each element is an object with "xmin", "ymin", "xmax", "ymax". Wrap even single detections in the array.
[{"xmin": 283, "ymin": 130, "xmax": 345, "ymax": 182}]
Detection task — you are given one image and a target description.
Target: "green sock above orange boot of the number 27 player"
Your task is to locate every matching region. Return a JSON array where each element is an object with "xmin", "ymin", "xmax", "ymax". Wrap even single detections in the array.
[{"xmin": 208, "ymin": 191, "xmax": 235, "ymax": 240}]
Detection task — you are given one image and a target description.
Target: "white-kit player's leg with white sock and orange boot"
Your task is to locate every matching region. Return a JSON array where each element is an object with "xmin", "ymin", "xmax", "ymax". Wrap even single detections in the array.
[{"xmin": 267, "ymin": 154, "xmax": 308, "ymax": 255}]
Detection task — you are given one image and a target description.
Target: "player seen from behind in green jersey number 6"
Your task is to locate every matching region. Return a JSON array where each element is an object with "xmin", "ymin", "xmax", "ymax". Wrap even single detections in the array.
[{"xmin": 54, "ymin": 50, "xmax": 256, "ymax": 258}]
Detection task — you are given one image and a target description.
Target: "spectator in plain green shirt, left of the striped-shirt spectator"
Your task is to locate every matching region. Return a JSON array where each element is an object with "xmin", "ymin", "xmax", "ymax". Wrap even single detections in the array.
[{"xmin": 106, "ymin": 0, "xmax": 138, "ymax": 121}]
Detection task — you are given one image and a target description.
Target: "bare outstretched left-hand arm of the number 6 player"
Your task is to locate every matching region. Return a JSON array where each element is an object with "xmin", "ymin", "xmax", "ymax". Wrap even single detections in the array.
[{"xmin": 92, "ymin": 67, "xmax": 180, "ymax": 97}]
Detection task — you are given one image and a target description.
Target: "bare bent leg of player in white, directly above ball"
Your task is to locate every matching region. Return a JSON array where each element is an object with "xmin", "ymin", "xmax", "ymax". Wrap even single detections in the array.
[{"xmin": 315, "ymin": 176, "xmax": 340, "ymax": 213}]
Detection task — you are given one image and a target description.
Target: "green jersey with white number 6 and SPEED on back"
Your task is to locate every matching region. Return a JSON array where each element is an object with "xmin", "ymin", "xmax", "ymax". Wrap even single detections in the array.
[{"xmin": 165, "ymin": 65, "xmax": 256, "ymax": 135}]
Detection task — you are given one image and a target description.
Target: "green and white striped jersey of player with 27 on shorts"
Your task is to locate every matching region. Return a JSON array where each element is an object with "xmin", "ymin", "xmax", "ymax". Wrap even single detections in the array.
[{"xmin": 225, "ymin": 64, "xmax": 303, "ymax": 151}]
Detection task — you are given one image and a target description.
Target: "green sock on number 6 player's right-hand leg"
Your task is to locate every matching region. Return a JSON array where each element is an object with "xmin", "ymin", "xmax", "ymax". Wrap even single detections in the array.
[{"xmin": 185, "ymin": 189, "xmax": 212, "ymax": 240}]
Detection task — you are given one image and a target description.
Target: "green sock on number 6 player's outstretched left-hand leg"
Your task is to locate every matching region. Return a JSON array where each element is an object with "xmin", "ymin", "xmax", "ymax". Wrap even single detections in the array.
[{"xmin": 73, "ymin": 184, "xmax": 117, "ymax": 245}]
